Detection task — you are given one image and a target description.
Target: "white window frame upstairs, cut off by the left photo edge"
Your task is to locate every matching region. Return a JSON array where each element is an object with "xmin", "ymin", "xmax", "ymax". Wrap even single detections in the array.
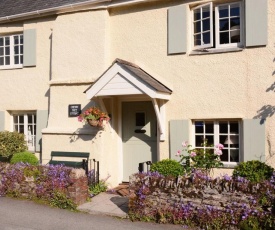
[{"xmin": 0, "ymin": 33, "xmax": 24, "ymax": 69}]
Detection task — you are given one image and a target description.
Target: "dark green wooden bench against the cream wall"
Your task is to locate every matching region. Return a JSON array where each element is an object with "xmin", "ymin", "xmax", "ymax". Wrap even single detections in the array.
[{"xmin": 48, "ymin": 151, "xmax": 90, "ymax": 174}]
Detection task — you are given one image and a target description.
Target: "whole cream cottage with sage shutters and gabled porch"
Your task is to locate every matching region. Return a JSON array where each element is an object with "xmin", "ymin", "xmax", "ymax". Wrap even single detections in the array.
[{"xmin": 0, "ymin": 0, "xmax": 275, "ymax": 186}]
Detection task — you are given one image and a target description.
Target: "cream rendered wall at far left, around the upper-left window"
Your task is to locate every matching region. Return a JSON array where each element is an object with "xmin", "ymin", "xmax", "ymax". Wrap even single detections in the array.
[{"xmin": 0, "ymin": 18, "xmax": 54, "ymax": 130}]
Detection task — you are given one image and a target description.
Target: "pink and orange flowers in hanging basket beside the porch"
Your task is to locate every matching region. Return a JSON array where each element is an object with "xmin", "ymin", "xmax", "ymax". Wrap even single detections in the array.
[{"xmin": 78, "ymin": 107, "xmax": 110, "ymax": 126}]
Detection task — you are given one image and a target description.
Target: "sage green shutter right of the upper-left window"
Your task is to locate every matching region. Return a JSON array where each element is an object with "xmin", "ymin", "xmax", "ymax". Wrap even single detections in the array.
[{"xmin": 23, "ymin": 29, "xmax": 36, "ymax": 67}]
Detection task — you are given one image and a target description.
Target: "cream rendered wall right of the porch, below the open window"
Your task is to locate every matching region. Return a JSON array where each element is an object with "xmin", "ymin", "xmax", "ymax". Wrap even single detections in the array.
[{"xmin": 110, "ymin": 0, "xmax": 275, "ymax": 169}]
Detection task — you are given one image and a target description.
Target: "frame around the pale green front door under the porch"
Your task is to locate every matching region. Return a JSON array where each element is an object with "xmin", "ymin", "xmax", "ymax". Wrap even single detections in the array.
[{"xmin": 117, "ymin": 95, "xmax": 160, "ymax": 181}]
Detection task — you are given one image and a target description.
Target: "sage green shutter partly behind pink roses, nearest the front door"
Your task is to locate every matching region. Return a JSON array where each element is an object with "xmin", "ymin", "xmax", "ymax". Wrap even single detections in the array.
[{"xmin": 169, "ymin": 120, "xmax": 190, "ymax": 161}]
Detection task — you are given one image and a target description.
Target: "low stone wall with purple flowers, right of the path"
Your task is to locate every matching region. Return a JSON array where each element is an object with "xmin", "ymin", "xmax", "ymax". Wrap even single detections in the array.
[{"xmin": 129, "ymin": 171, "xmax": 275, "ymax": 229}]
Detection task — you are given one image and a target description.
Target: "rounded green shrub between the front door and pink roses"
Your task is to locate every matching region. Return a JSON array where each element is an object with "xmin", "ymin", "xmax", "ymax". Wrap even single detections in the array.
[{"xmin": 150, "ymin": 159, "xmax": 183, "ymax": 177}]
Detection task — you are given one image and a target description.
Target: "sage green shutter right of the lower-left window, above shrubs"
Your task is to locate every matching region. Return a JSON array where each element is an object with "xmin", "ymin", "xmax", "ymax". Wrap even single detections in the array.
[{"xmin": 35, "ymin": 110, "xmax": 48, "ymax": 152}]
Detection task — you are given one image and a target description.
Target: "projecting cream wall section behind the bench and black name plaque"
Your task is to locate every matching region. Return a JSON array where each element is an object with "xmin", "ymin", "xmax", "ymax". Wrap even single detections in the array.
[{"xmin": 43, "ymin": 10, "xmax": 122, "ymax": 187}]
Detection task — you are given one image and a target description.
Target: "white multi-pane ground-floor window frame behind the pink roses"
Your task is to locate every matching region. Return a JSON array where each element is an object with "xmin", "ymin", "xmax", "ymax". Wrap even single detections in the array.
[{"xmin": 192, "ymin": 119, "xmax": 242, "ymax": 166}]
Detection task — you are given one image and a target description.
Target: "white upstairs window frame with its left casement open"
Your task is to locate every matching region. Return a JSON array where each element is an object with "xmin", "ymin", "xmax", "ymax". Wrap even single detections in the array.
[{"xmin": 191, "ymin": 1, "xmax": 244, "ymax": 50}]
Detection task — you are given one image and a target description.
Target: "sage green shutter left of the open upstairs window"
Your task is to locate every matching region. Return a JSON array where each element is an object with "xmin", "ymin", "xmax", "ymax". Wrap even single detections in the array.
[{"xmin": 167, "ymin": 5, "xmax": 187, "ymax": 54}]
